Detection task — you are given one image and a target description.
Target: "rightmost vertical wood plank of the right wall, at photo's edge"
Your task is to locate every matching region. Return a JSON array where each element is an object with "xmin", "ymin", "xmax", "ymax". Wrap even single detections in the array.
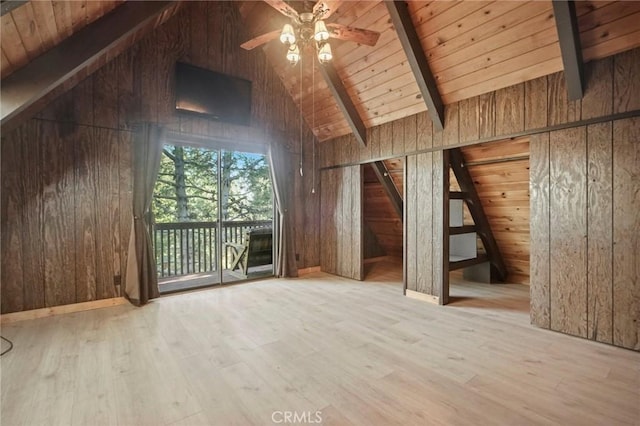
[{"xmin": 613, "ymin": 117, "xmax": 640, "ymax": 350}]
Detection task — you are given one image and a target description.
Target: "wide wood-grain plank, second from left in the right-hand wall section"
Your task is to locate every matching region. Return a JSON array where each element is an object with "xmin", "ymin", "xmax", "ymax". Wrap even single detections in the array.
[{"xmin": 549, "ymin": 127, "xmax": 587, "ymax": 337}]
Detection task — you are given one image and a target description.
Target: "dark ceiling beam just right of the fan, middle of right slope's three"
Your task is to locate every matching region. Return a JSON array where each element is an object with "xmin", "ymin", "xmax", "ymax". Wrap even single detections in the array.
[{"xmin": 384, "ymin": 0, "xmax": 444, "ymax": 130}]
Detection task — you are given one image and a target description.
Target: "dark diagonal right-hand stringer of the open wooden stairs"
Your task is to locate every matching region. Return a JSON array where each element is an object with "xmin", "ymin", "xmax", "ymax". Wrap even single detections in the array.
[{"xmin": 445, "ymin": 148, "xmax": 507, "ymax": 281}]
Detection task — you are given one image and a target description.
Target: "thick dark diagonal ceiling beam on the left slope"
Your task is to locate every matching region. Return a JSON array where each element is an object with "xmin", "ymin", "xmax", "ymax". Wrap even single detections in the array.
[{"xmin": 0, "ymin": 1, "xmax": 176, "ymax": 131}]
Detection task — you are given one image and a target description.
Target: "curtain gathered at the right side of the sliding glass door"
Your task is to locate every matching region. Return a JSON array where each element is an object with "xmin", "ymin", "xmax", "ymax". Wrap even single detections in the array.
[{"xmin": 269, "ymin": 144, "xmax": 298, "ymax": 277}]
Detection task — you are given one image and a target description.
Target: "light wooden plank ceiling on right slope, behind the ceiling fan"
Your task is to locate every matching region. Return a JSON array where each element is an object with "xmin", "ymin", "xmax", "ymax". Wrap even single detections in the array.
[{"xmin": 240, "ymin": 1, "xmax": 640, "ymax": 141}]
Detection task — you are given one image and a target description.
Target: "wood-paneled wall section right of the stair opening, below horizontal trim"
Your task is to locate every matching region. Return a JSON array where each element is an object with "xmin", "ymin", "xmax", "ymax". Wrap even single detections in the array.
[{"xmin": 531, "ymin": 117, "xmax": 640, "ymax": 350}]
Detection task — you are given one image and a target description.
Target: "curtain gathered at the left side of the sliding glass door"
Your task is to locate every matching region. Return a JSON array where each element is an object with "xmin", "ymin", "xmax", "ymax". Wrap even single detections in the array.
[{"xmin": 125, "ymin": 123, "xmax": 164, "ymax": 306}]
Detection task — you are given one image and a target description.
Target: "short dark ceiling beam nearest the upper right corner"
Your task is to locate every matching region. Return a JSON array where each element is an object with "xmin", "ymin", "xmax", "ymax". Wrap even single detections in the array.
[{"xmin": 552, "ymin": 0, "xmax": 584, "ymax": 101}]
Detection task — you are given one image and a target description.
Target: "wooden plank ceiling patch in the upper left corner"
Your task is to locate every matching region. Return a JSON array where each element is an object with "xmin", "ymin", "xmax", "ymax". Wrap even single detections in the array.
[{"xmin": 0, "ymin": 0, "xmax": 124, "ymax": 78}]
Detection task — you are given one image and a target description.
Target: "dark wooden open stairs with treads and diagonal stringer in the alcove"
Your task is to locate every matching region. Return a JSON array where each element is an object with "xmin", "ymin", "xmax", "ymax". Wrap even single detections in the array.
[{"xmin": 444, "ymin": 148, "xmax": 507, "ymax": 281}]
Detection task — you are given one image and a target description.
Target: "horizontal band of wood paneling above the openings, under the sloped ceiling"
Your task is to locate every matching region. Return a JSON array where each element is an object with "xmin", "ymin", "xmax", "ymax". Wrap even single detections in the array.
[{"xmin": 320, "ymin": 48, "xmax": 640, "ymax": 168}]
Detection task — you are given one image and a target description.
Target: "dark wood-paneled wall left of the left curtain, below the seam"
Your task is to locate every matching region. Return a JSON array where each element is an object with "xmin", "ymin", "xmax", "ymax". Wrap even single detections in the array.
[{"xmin": 2, "ymin": 120, "xmax": 132, "ymax": 313}]
